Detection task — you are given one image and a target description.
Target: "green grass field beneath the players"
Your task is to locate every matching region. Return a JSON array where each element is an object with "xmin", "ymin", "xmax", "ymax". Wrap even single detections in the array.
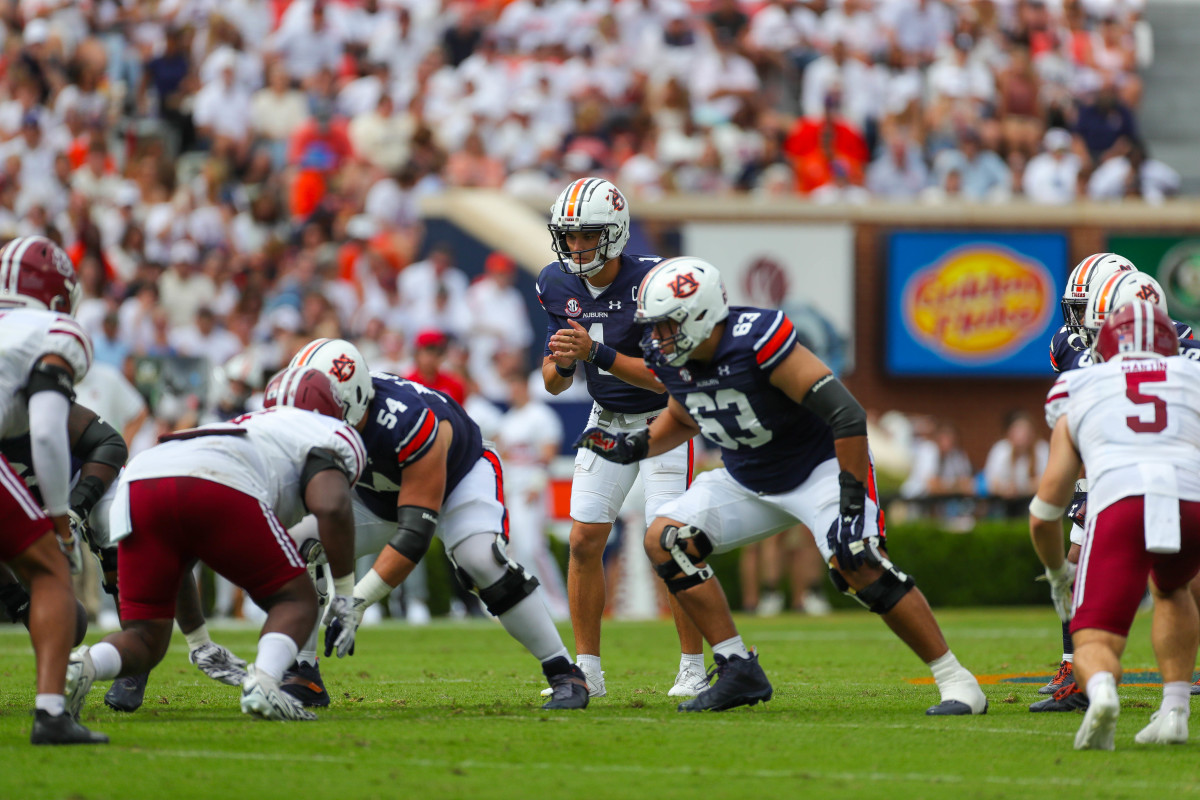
[{"xmin": 0, "ymin": 609, "xmax": 1200, "ymax": 800}]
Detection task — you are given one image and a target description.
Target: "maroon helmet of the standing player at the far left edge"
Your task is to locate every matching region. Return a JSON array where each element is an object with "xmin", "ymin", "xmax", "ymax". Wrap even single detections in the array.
[{"xmin": 0, "ymin": 236, "xmax": 83, "ymax": 317}]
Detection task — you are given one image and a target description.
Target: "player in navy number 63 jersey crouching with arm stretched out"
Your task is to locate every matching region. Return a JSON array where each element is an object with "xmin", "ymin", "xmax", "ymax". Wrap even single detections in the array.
[{"xmin": 580, "ymin": 258, "xmax": 988, "ymax": 716}]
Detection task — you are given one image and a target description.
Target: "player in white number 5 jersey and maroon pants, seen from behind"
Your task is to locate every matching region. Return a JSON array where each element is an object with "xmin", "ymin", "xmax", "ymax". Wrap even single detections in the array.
[{"xmin": 1030, "ymin": 300, "xmax": 1200, "ymax": 750}]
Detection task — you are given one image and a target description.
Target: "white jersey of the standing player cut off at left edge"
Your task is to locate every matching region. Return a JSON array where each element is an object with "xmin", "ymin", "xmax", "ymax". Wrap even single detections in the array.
[{"xmin": 0, "ymin": 308, "xmax": 91, "ymax": 439}]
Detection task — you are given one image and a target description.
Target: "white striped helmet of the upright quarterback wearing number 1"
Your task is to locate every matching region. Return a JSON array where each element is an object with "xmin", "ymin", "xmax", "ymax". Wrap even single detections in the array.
[{"xmin": 547, "ymin": 178, "xmax": 629, "ymax": 275}]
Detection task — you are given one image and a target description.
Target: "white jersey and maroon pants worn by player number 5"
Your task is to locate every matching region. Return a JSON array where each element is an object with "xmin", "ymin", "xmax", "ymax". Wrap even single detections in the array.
[{"xmin": 1046, "ymin": 356, "xmax": 1200, "ymax": 636}]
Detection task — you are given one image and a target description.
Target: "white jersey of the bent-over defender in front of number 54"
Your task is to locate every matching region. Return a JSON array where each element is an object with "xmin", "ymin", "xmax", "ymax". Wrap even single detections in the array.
[{"xmin": 121, "ymin": 405, "xmax": 367, "ymax": 528}]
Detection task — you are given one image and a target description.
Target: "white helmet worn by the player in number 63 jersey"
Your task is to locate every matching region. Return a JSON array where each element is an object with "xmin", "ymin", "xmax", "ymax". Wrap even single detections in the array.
[{"xmin": 634, "ymin": 255, "xmax": 730, "ymax": 367}]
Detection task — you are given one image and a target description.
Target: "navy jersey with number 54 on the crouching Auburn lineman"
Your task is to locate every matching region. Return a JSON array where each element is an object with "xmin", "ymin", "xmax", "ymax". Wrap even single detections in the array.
[{"xmin": 354, "ymin": 372, "xmax": 484, "ymax": 522}]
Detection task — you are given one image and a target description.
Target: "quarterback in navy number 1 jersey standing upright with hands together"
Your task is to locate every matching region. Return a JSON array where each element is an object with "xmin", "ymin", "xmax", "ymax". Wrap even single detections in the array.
[{"xmin": 536, "ymin": 178, "xmax": 708, "ymax": 697}]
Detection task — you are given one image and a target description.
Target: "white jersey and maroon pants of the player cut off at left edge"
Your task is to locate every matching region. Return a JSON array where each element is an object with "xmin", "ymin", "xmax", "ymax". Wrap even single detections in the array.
[{"xmin": 0, "ymin": 308, "xmax": 91, "ymax": 560}]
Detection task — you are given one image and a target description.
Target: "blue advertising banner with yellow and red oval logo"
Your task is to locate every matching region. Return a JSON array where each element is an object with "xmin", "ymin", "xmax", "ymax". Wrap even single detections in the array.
[{"xmin": 884, "ymin": 231, "xmax": 1067, "ymax": 378}]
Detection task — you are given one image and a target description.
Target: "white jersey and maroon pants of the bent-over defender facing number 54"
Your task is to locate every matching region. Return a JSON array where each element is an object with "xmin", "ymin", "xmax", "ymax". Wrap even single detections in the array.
[{"xmin": 110, "ymin": 407, "xmax": 366, "ymax": 619}]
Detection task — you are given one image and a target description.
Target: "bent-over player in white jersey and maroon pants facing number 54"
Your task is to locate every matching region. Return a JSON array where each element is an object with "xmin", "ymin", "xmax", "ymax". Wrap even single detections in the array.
[{"xmin": 67, "ymin": 368, "xmax": 366, "ymax": 720}]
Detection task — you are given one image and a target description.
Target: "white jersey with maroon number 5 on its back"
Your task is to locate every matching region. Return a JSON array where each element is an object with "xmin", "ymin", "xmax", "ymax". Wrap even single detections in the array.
[{"xmin": 1046, "ymin": 356, "xmax": 1200, "ymax": 518}]
